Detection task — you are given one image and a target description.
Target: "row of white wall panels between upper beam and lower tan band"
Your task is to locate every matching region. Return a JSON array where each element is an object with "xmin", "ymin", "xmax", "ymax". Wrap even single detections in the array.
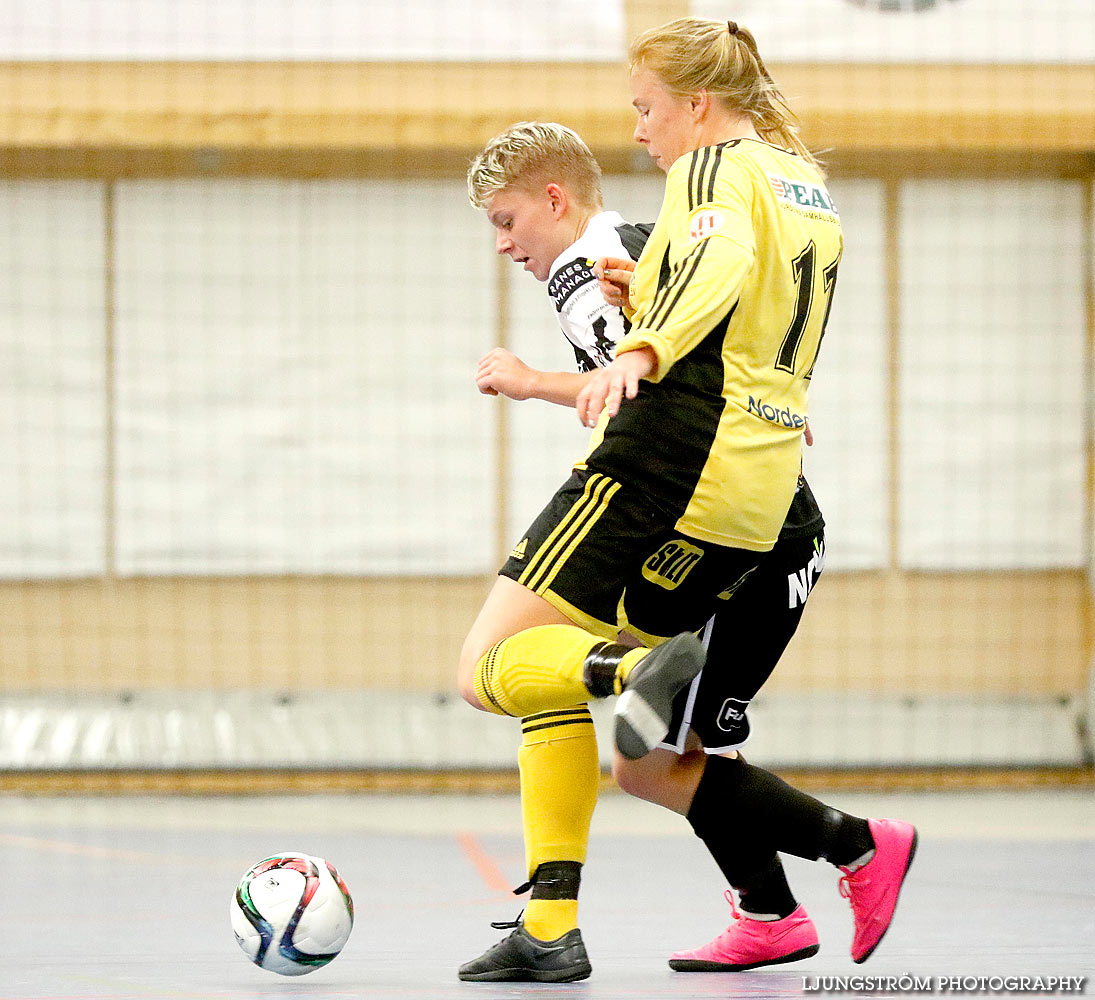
[{"xmin": 0, "ymin": 174, "xmax": 1090, "ymax": 577}]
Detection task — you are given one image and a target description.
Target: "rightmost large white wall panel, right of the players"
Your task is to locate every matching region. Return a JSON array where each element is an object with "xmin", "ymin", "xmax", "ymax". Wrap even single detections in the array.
[{"xmin": 900, "ymin": 180, "xmax": 1086, "ymax": 570}]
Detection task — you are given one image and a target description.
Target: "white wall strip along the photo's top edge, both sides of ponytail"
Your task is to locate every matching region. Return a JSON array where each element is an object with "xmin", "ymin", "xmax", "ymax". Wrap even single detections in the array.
[{"xmin": 0, "ymin": 0, "xmax": 1095, "ymax": 64}]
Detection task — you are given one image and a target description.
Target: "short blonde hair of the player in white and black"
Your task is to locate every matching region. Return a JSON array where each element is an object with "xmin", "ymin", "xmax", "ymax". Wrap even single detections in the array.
[{"xmin": 468, "ymin": 122, "xmax": 601, "ymax": 208}]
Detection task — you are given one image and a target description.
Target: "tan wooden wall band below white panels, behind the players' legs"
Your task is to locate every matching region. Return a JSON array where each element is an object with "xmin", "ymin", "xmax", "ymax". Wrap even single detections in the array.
[{"xmin": 0, "ymin": 573, "xmax": 1091, "ymax": 694}]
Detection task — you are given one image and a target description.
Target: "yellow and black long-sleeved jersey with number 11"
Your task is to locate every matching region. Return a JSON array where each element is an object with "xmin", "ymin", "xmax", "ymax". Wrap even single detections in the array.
[{"xmin": 585, "ymin": 139, "xmax": 843, "ymax": 551}]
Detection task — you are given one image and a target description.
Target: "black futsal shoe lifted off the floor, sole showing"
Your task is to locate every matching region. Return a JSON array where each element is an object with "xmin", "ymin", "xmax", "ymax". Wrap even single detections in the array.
[{"xmin": 615, "ymin": 632, "xmax": 707, "ymax": 760}]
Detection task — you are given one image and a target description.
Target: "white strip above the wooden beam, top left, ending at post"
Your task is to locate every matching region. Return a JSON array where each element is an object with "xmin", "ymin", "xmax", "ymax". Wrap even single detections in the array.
[{"xmin": 0, "ymin": 0, "xmax": 624, "ymax": 61}]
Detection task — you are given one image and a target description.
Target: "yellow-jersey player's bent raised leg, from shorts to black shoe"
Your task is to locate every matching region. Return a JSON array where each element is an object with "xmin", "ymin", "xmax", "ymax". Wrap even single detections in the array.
[{"xmin": 460, "ymin": 470, "xmax": 703, "ymax": 731}]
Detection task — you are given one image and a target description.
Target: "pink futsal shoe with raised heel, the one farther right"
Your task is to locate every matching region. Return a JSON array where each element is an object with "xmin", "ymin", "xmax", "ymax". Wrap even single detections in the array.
[{"xmin": 840, "ymin": 819, "xmax": 917, "ymax": 963}]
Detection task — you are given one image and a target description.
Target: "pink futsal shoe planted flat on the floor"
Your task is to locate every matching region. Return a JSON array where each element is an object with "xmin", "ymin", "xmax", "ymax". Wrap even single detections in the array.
[{"xmin": 669, "ymin": 889, "xmax": 818, "ymax": 973}]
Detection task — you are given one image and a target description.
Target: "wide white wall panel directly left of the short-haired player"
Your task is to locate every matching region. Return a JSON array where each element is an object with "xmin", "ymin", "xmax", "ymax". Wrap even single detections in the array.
[{"xmin": 117, "ymin": 175, "xmax": 494, "ymax": 574}]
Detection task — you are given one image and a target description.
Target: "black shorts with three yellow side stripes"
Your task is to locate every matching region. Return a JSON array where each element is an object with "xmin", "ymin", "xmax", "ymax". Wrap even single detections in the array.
[{"xmin": 499, "ymin": 469, "xmax": 766, "ymax": 645}]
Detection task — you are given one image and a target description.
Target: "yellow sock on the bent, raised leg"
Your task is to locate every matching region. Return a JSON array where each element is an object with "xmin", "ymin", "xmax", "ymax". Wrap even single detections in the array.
[{"xmin": 475, "ymin": 625, "xmax": 649, "ymax": 717}]
